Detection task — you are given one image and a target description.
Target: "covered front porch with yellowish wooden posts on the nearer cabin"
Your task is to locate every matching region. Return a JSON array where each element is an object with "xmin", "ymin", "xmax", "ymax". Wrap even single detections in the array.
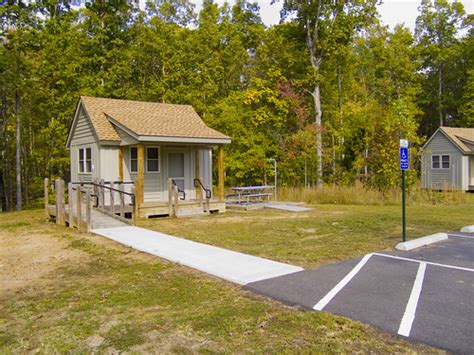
[{"xmin": 118, "ymin": 142, "xmax": 229, "ymax": 218}]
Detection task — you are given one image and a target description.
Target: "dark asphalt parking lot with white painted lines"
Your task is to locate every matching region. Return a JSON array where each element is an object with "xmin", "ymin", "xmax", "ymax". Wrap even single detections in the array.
[{"xmin": 246, "ymin": 232, "xmax": 474, "ymax": 354}]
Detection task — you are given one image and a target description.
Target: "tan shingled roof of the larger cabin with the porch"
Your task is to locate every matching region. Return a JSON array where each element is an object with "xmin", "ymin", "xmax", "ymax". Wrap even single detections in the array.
[{"xmin": 70, "ymin": 96, "xmax": 230, "ymax": 143}]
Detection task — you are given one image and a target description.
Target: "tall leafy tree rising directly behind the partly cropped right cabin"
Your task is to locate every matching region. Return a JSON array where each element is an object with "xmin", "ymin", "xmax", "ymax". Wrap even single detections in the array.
[{"xmin": 415, "ymin": 0, "xmax": 472, "ymax": 135}]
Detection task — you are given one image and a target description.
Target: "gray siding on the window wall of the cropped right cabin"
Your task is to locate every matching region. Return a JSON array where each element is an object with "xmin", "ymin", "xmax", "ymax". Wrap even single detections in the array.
[{"xmin": 421, "ymin": 131, "xmax": 467, "ymax": 190}]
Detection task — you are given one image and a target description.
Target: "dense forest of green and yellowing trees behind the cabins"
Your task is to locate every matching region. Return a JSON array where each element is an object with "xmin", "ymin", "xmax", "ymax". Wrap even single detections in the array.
[{"xmin": 0, "ymin": 0, "xmax": 474, "ymax": 211}]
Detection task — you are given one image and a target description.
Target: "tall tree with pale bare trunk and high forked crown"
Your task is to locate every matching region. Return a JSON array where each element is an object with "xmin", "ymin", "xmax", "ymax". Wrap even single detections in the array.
[{"xmin": 282, "ymin": 0, "xmax": 377, "ymax": 186}]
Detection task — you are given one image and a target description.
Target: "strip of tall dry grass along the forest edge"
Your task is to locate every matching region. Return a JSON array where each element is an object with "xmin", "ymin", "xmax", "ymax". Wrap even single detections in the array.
[{"xmin": 278, "ymin": 183, "xmax": 474, "ymax": 205}]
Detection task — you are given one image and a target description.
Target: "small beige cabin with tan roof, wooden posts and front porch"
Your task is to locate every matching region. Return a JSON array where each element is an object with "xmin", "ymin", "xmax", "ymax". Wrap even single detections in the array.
[{"xmin": 67, "ymin": 96, "xmax": 231, "ymax": 218}]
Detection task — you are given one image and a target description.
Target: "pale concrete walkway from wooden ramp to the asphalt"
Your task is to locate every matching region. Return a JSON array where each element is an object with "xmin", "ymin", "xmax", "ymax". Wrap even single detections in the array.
[{"xmin": 92, "ymin": 226, "xmax": 303, "ymax": 285}]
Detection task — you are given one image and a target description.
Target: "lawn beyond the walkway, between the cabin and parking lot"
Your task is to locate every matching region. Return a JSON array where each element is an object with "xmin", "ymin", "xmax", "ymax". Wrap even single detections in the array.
[{"xmin": 140, "ymin": 202, "xmax": 474, "ymax": 268}]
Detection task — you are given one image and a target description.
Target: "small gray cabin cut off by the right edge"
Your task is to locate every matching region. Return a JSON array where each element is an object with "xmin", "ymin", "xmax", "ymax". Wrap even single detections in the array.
[{"xmin": 421, "ymin": 127, "xmax": 474, "ymax": 191}]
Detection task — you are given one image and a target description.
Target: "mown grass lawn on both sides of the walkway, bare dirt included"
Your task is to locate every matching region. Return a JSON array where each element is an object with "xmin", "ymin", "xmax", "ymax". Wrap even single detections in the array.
[{"xmin": 0, "ymin": 206, "xmax": 446, "ymax": 353}]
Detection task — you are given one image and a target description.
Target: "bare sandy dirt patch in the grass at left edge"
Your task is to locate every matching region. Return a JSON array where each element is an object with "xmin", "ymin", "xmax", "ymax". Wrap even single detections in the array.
[{"xmin": 0, "ymin": 231, "xmax": 88, "ymax": 300}]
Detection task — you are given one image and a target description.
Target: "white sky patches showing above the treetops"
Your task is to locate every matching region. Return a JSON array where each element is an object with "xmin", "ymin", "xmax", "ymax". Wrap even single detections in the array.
[{"xmin": 191, "ymin": 0, "xmax": 474, "ymax": 31}]
